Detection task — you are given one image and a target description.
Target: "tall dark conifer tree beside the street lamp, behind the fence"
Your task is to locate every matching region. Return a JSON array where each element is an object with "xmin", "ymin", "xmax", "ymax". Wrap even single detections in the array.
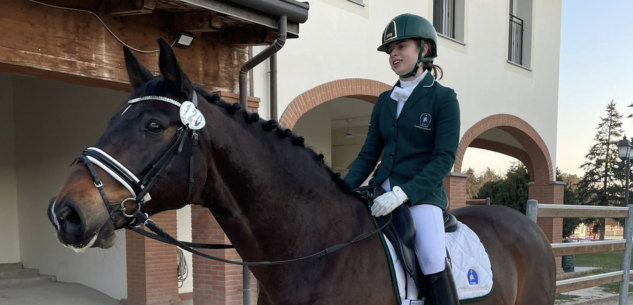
[{"xmin": 578, "ymin": 100, "xmax": 624, "ymax": 240}]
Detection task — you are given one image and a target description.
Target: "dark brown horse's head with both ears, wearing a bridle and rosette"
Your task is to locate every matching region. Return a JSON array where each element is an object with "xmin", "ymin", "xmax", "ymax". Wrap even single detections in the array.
[{"xmin": 47, "ymin": 39, "xmax": 206, "ymax": 252}]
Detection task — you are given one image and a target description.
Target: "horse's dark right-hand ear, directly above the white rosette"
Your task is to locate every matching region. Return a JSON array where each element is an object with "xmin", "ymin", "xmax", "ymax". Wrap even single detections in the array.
[{"xmin": 158, "ymin": 38, "xmax": 193, "ymax": 99}]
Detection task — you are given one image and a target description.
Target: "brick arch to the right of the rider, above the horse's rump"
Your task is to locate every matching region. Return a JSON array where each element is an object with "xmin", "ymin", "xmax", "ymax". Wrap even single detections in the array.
[{"xmin": 454, "ymin": 114, "xmax": 554, "ymax": 182}]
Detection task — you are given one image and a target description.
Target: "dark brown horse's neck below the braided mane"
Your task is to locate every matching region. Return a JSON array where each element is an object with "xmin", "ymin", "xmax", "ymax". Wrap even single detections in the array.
[{"xmin": 200, "ymin": 105, "xmax": 371, "ymax": 286}]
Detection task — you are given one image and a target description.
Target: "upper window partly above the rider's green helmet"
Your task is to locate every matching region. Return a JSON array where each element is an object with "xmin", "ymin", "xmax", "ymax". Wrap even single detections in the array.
[{"xmin": 433, "ymin": 0, "xmax": 465, "ymax": 42}]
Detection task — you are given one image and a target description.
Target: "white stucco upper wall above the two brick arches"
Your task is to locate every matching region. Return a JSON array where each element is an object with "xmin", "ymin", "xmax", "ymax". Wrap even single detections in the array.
[{"xmin": 254, "ymin": 0, "xmax": 562, "ymax": 178}]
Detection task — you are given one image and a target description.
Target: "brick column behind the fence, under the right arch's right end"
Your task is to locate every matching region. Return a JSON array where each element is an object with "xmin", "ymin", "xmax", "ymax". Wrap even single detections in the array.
[{"xmin": 528, "ymin": 181, "xmax": 565, "ymax": 274}]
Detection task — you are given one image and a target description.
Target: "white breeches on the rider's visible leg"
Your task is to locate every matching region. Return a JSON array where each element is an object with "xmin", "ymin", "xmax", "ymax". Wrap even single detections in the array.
[{"xmin": 411, "ymin": 204, "xmax": 446, "ymax": 275}]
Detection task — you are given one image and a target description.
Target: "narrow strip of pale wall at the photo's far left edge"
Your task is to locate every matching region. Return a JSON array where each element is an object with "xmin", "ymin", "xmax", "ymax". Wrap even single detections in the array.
[{"xmin": 0, "ymin": 73, "xmax": 20, "ymax": 264}]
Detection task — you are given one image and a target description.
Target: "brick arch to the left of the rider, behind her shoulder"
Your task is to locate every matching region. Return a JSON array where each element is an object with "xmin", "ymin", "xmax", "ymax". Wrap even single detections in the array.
[{"xmin": 279, "ymin": 78, "xmax": 392, "ymax": 129}]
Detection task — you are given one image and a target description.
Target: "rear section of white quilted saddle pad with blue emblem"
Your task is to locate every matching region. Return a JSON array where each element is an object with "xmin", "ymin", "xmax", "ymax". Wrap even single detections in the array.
[{"xmin": 446, "ymin": 222, "xmax": 492, "ymax": 301}]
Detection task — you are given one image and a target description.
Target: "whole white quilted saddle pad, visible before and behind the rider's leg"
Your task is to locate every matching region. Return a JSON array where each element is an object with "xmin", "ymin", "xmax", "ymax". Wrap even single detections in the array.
[{"xmin": 385, "ymin": 222, "xmax": 492, "ymax": 305}]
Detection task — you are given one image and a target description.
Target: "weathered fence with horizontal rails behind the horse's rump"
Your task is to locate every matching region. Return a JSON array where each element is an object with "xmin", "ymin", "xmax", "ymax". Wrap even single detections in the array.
[{"xmin": 525, "ymin": 200, "xmax": 633, "ymax": 305}]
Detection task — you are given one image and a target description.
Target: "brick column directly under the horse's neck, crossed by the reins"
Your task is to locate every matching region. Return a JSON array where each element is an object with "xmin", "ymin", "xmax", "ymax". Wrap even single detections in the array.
[{"xmin": 191, "ymin": 205, "xmax": 257, "ymax": 305}]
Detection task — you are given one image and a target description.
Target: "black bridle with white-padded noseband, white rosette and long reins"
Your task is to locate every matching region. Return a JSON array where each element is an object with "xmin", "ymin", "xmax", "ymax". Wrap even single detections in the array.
[{"xmin": 73, "ymin": 91, "xmax": 391, "ymax": 266}]
